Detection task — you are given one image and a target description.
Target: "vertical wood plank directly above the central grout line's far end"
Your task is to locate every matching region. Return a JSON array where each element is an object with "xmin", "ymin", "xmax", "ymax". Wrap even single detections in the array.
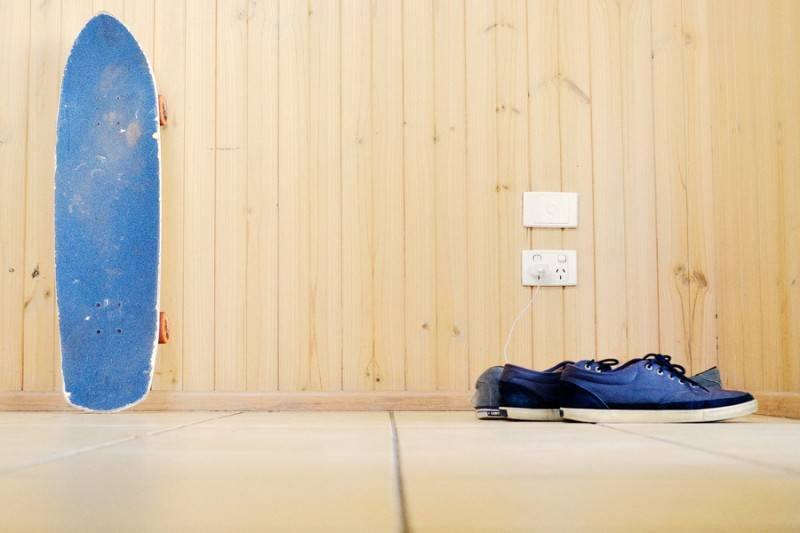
[{"xmin": 372, "ymin": 2, "xmax": 406, "ymax": 390}]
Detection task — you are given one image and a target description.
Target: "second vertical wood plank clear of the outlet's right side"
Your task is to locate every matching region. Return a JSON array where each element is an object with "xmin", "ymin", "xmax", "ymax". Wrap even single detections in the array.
[{"xmin": 619, "ymin": 0, "xmax": 658, "ymax": 356}]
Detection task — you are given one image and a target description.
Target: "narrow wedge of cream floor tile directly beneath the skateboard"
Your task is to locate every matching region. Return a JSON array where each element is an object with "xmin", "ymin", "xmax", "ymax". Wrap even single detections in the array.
[{"xmin": 0, "ymin": 412, "xmax": 228, "ymax": 474}]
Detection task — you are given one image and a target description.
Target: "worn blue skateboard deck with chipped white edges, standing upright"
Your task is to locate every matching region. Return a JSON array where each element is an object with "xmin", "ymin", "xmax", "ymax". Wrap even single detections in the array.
[{"xmin": 55, "ymin": 14, "xmax": 161, "ymax": 411}]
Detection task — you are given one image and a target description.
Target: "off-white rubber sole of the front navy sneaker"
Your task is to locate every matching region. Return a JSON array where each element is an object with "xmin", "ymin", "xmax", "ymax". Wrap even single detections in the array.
[{"xmin": 561, "ymin": 400, "xmax": 758, "ymax": 424}]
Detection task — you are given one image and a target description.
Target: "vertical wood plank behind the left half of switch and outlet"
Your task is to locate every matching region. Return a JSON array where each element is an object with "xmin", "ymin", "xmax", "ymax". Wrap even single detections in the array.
[{"xmin": 528, "ymin": 0, "xmax": 564, "ymax": 369}]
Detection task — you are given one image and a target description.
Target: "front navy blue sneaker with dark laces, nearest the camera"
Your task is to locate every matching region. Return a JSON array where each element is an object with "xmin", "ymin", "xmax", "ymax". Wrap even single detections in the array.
[{"xmin": 561, "ymin": 354, "xmax": 758, "ymax": 423}]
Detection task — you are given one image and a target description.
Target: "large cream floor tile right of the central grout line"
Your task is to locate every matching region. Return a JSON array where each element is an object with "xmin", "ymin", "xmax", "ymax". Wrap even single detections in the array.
[{"xmin": 396, "ymin": 413, "xmax": 800, "ymax": 532}]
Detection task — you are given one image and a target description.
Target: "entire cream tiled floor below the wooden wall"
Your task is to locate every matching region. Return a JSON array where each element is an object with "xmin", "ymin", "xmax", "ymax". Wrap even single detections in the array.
[{"xmin": 0, "ymin": 412, "xmax": 800, "ymax": 532}]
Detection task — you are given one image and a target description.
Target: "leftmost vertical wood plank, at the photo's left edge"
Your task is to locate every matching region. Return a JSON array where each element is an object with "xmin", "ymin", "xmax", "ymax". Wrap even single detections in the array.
[{"xmin": 0, "ymin": 2, "xmax": 31, "ymax": 391}]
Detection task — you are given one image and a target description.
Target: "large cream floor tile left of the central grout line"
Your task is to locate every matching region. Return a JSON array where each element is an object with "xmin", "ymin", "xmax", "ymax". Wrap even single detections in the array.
[{"xmin": 0, "ymin": 413, "xmax": 399, "ymax": 532}]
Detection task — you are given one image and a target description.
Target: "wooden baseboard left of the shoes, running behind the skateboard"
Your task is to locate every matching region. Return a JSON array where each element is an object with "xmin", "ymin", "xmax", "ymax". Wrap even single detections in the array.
[{"xmin": 0, "ymin": 391, "xmax": 472, "ymax": 411}]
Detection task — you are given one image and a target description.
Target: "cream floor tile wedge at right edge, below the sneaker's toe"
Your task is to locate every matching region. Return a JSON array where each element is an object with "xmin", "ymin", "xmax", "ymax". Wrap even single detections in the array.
[{"xmin": 608, "ymin": 416, "xmax": 800, "ymax": 475}]
